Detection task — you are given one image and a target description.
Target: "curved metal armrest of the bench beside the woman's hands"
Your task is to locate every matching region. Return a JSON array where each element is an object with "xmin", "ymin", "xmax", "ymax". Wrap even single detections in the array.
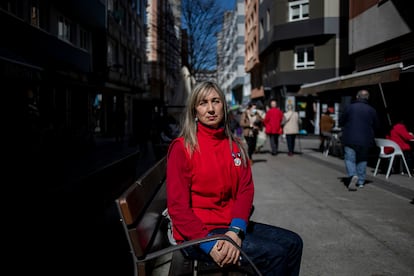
[{"xmin": 140, "ymin": 234, "xmax": 262, "ymax": 276}]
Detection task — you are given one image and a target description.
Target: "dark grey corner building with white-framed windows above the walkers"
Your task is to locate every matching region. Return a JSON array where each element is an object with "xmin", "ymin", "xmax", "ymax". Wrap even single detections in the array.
[{"xmin": 258, "ymin": 0, "xmax": 352, "ymax": 133}]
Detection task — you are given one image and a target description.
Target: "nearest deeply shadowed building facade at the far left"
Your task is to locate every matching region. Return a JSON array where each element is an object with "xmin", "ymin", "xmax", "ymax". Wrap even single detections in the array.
[{"xmin": 0, "ymin": 0, "xmax": 106, "ymax": 154}]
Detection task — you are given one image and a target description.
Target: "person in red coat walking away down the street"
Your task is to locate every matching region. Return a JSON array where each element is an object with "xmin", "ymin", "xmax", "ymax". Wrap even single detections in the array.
[{"xmin": 263, "ymin": 99, "xmax": 283, "ymax": 155}]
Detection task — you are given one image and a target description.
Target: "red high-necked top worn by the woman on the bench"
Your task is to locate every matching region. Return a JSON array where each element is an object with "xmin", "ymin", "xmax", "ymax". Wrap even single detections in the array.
[{"xmin": 167, "ymin": 123, "xmax": 254, "ymax": 242}]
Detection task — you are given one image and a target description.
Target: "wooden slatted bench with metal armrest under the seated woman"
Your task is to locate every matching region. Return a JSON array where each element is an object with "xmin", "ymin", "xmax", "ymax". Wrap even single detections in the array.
[{"xmin": 115, "ymin": 157, "xmax": 260, "ymax": 276}]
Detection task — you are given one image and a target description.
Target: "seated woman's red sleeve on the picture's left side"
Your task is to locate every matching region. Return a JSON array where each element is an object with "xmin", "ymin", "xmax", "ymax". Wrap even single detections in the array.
[{"xmin": 166, "ymin": 139, "xmax": 208, "ymax": 241}]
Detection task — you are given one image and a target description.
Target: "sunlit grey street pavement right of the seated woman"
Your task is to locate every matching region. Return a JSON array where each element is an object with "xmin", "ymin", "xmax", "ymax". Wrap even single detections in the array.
[{"xmin": 252, "ymin": 136, "xmax": 414, "ymax": 276}]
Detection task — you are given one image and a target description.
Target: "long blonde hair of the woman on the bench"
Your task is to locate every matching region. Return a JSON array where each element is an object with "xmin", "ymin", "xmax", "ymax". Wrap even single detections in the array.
[{"xmin": 180, "ymin": 81, "xmax": 247, "ymax": 165}]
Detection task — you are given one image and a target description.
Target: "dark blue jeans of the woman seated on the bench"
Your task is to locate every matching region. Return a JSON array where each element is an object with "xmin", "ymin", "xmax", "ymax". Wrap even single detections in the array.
[{"xmin": 184, "ymin": 221, "xmax": 303, "ymax": 276}]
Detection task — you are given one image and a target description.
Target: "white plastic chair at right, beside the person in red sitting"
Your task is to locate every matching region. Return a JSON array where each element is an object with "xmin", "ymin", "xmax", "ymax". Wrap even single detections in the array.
[{"xmin": 374, "ymin": 138, "xmax": 411, "ymax": 178}]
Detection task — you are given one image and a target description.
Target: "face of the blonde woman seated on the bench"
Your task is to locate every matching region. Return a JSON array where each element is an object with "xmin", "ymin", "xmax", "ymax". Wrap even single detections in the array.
[{"xmin": 195, "ymin": 89, "xmax": 224, "ymax": 128}]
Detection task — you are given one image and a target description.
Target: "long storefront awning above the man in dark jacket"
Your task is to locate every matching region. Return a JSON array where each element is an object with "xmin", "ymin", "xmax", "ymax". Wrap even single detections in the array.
[{"xmin": 298, "ymin": 62, "xmax": 403, "ymax": 95}]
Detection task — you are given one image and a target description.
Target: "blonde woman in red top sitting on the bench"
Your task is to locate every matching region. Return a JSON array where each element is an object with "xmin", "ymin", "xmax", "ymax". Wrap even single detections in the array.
[{"xmin": 166, "ymin": 81, "xmax": 303, "ymax": 275}]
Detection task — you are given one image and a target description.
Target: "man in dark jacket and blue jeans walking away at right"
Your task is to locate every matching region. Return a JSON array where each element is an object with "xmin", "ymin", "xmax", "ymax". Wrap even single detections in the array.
[{"xmin": 339, "ymin": 90, "xmax": 379, "ymax": 191}]
